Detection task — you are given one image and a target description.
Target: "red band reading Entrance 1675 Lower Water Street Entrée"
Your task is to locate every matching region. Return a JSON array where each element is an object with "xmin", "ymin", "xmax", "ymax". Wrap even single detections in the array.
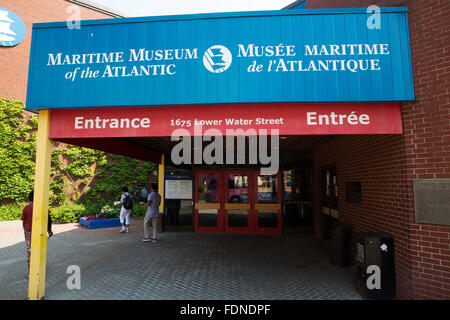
[{"xmin": 49, "ymin": 103, "xmax": 402, "ymax": 138}]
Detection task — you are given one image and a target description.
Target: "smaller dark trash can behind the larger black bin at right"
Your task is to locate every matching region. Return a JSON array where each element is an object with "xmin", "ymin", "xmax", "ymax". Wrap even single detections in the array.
[{"xmin": 330, "ymin": 223, "xmax": 350, "ymax": 267}]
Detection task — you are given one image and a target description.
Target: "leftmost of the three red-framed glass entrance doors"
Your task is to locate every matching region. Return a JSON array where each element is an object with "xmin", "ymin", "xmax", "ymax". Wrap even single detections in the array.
[{"xmin": 194, "ymin": 171, "xmax": 223, "ymax": 232}]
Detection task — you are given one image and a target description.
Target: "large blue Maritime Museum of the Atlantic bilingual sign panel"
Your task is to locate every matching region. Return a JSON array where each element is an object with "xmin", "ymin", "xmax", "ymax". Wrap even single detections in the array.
[{"xmin": 27, "ymin": 7, "xmax": 414, "ymax": 110}]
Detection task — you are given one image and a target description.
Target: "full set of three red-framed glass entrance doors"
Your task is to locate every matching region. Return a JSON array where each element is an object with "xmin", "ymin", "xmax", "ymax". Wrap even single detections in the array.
[{"xmin": 194, "ymin": 170, "xmax": 282, "ymax": 234}]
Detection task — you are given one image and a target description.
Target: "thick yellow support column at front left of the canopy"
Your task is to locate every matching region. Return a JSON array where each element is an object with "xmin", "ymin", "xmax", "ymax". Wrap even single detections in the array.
[{"xmin": 28, "ymin": 110, "xmax": 52, "ymax": 300}]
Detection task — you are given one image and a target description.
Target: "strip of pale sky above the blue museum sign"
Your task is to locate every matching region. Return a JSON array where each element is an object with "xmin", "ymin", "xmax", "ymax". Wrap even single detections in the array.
[{"xmin": 91, "ymin": 0, "xmax": 295, "ymax": 16}]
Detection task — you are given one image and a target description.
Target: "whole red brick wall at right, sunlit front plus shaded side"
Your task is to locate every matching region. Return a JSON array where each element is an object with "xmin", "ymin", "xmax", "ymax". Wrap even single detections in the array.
[{"xmin": 306, "ymin": 0, "xmax": 450, "ymax": 299}]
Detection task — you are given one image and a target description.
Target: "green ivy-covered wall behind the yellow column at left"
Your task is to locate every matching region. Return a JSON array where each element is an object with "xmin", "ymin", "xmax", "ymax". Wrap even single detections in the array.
[{"xmin": 0, "ymin": 98, "xmax": 157, "ymax": 207}]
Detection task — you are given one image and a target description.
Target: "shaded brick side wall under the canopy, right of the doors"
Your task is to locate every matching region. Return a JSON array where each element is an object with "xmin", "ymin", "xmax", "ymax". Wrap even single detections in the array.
[{"xmin": 314, "ymin": 135, "xmax": 411, "ymax": 299}]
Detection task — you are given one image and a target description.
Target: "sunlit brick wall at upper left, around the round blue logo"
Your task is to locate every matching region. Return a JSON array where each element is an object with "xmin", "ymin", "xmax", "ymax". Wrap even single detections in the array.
[{"xmin": 0, "ymin": 0, "xmax": 111, "ymax": 102}]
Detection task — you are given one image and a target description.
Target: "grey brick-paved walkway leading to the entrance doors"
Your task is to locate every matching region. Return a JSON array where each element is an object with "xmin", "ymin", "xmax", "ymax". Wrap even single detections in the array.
[{"xmin": 0, "ymin": 218, "xmax": 361, "ymax": 300}]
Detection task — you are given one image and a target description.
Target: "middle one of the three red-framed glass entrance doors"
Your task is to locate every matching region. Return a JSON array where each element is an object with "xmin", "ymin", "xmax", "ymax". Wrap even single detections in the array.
[{"xmin": 224, "ymin": 171, "xmax": 253, "ymax": 233}]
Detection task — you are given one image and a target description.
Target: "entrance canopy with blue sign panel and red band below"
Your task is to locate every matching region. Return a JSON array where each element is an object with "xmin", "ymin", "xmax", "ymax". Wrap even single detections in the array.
[{"xmin": 27, "ymin": 7, "xmax": 414, "ymax": 162}]
